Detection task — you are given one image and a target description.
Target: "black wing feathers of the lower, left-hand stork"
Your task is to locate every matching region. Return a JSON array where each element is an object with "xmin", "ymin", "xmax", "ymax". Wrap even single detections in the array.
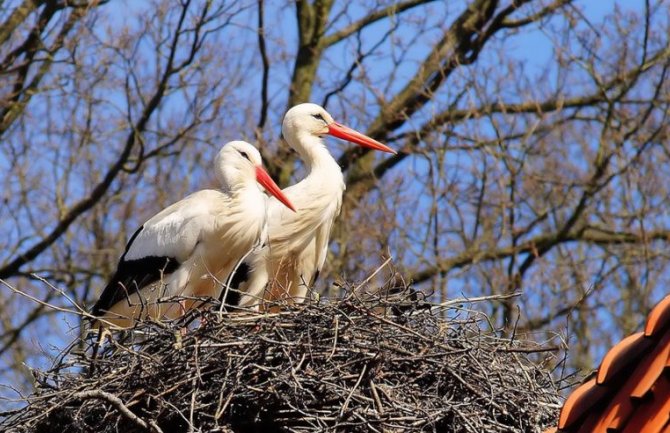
[{"xmin": 91, "ymin": 226, "xmax": 180, "ymax": 316}]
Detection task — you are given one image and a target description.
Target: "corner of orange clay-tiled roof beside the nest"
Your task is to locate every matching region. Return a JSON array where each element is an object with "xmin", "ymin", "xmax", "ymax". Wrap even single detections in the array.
[{"xmin": 545, "ymin": 296, "xmax": 670, "ymax": 433}]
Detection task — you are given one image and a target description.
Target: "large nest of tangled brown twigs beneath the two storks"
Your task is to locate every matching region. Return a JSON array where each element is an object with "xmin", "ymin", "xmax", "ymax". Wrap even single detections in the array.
[{"xmin": 0, "ymin": 290, "xmax": 560, "ymax": 433}]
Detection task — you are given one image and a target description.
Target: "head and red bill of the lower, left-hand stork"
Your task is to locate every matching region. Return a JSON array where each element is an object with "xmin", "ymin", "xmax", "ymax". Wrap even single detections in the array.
[{"xmin": 215, "ymin": 141, "xmax": 295, "ymax": 212}]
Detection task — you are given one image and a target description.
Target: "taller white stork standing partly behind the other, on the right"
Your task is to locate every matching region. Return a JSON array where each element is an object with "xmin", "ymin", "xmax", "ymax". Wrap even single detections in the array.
[{"xmin": 231, "ymin": 104, "xmax": 396, "ymax": 307}]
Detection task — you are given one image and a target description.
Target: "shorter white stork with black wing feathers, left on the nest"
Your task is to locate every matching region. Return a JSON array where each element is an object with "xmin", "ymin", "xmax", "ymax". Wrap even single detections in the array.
[{"xmin": 92, "ymin": 141, "xmax": 294, "ymax": 328}]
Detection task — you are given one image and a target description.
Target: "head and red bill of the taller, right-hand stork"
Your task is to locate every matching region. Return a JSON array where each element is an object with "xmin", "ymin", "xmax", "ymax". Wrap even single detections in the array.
[{"xmin": 282, "ymin": 103, "xmax": 396, "ymax": 153}]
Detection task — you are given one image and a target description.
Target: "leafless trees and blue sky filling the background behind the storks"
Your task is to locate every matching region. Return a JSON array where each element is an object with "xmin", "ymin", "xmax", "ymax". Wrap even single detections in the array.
[{"xmin": 0, "ymin": 0, "xmax": 670, "ymax": 398}]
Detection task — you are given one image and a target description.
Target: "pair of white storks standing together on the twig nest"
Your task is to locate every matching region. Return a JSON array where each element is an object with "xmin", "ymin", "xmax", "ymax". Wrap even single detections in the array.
[{"xmin": 92, "ymin": 104, "xmax": 395, "ymax": 327}]
